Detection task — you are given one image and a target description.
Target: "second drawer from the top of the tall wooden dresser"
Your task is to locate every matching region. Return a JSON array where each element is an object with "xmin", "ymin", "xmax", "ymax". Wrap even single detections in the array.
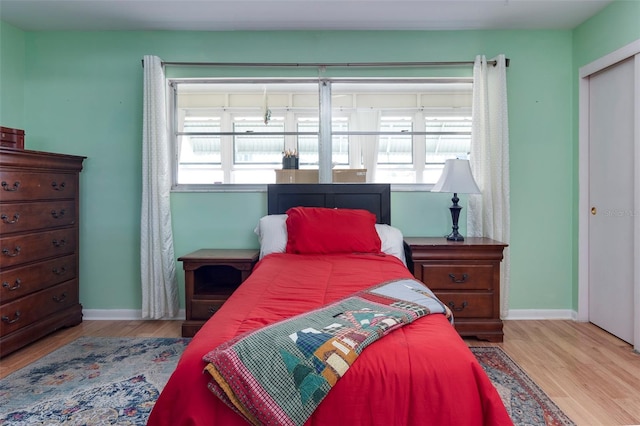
[{"xmin": 0, "ymin": 200, "xmax": 77, "ymax": 234}]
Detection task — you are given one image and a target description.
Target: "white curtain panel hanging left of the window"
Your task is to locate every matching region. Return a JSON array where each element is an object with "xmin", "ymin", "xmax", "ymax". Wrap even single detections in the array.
[{"xmin": 140, "ymin": 55, "xmax": 178, "ymax": 319}]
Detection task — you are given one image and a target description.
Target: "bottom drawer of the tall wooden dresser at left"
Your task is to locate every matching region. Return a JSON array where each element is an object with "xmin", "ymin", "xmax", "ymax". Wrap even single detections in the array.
[{"xmin": 0, "ymin": 280, "xmax": 78, "ymax": 336}]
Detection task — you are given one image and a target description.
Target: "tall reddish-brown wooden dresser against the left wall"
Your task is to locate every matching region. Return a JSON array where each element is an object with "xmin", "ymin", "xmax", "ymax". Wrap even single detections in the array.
[{"xmin": 0, "ymin": 148, "xmax": 85, "ymax": 357}]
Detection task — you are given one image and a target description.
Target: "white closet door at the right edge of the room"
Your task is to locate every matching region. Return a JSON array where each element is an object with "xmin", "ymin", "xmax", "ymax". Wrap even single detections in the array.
[{"xmin": 589, "ymin": 58, "xmax": 638, "ymax": 344}]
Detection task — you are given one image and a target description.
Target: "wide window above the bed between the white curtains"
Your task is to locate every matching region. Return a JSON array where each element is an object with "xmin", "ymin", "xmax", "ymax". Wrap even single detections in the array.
[{"xmin": 172, "ymin": 79, "xmax": 471, "ymax": 188}]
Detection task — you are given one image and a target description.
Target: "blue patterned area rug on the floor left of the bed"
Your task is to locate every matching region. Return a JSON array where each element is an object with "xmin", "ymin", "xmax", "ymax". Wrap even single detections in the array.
[{"xmin": 0, "ymin": 337, "xmax": 190, "ymax": 425}]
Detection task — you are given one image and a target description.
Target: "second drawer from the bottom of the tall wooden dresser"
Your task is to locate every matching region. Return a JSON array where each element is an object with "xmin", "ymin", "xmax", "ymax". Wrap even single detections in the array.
[{"xmin": 0, "ymin": 255, "xmax": 76, "ymax": 303}]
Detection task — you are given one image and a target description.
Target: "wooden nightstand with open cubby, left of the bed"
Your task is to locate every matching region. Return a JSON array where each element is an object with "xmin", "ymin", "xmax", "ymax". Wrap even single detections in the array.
[{"xmin": 178, "ymin": 249, "xmax": 259, "ymax": 337}]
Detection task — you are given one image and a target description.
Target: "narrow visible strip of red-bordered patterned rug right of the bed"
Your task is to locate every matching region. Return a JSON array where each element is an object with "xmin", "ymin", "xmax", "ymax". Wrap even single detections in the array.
[{"xmin": 469, "ymin": 346, "xmax": 575, "ymax": 426}]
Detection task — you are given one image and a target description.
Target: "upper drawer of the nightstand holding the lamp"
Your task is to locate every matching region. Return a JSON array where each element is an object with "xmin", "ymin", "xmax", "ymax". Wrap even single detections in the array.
[{"xmin": 419, "ymin": 264, "xmax": 494, "ymax": 291}]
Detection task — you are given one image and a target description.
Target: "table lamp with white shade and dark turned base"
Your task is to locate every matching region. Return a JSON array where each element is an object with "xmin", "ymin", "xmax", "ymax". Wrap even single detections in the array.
[{"xmin": 431, "ymin": 159, "xmax": 480, "ymax": 241}]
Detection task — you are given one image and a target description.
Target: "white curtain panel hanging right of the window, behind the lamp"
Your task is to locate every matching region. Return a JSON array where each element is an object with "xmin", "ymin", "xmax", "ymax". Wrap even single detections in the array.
[{"xmin": 467, "ymin": 55, "xmax": 511, "ymax": 318}]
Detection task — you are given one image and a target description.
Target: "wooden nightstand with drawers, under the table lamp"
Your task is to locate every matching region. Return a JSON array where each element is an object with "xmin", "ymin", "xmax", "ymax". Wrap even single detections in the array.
[{"xmin": 405, "ymin": 237, "xmax": 507, "ymax": 342}]
